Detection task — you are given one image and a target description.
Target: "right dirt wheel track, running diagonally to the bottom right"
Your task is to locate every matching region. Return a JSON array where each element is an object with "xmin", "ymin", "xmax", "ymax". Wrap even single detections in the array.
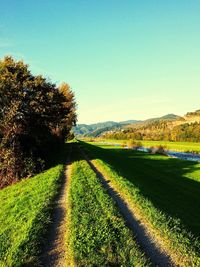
[{"xmin": 83, "ymin": 152, "xmax": 174, "ymax": 267}]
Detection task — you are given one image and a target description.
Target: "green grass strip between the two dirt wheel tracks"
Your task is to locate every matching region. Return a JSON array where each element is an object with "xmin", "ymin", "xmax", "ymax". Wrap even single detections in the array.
[{"xmin": 68, "ymin": 147, "xmax": 149, "ymax": 267}]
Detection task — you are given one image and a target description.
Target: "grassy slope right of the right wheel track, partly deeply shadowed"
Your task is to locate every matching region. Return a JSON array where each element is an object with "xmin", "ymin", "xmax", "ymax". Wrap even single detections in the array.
[{"xmin": 82, "ymin": 143, "xmax": 200, "ymax": 266}]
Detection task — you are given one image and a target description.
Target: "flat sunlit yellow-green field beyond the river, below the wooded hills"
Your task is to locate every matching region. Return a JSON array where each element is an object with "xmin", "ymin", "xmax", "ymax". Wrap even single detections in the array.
[{"xmin": 102, "ymin": 139, "xmax": 200, "ymax": 153}]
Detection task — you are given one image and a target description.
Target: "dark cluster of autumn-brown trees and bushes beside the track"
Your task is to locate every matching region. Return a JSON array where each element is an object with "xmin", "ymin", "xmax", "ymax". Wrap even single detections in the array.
[{"xmin": 0, "ymin": 57, "xmax": 76, "ymax": 188}]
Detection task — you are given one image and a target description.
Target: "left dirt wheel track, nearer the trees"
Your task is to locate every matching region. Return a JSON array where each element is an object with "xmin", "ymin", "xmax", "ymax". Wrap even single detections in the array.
[{"xmin": 41, "ymin": 147, "xmax": 71, "ymax": 267}]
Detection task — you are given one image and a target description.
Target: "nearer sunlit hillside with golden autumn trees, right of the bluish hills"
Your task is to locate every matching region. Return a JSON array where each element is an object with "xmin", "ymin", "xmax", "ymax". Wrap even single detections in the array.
[{"xmin": 102, "ymin": 110, "xmax": 200, "ymax": 142}]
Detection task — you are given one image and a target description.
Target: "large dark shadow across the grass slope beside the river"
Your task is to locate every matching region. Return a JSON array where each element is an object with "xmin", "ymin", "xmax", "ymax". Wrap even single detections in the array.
[{"xmin": 81, "ymin": 142, "xmax": 200, "ymax": 237}]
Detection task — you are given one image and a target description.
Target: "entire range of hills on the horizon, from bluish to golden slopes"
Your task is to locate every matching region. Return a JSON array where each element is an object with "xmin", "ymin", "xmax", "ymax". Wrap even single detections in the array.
[{"xmin": 73, "ymin": 110, "xmax": 200, "ymax": 140}]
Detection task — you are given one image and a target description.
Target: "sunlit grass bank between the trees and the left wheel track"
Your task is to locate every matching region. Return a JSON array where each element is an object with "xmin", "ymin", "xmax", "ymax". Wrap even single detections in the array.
[{"xmin": 0, "ymin": 146, "xmax": 69, "ymax": 267}]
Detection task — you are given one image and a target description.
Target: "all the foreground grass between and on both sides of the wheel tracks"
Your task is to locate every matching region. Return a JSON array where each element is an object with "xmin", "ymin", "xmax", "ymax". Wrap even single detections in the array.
[{"xmin": 0, "ymin": 142, "xmax": 200, "ymax": 267}]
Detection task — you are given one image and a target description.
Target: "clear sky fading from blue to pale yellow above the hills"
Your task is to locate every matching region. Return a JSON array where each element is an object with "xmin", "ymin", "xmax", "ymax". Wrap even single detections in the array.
[{"xmin": 0, "ymin": 0, "xmax": 200, "ymax": 123}]
